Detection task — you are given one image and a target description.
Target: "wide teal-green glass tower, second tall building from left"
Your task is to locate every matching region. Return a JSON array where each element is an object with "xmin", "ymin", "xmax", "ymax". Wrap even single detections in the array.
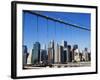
[{"xmin": 32, "ymin": 42, "xmax": 40, "ymax": 64}]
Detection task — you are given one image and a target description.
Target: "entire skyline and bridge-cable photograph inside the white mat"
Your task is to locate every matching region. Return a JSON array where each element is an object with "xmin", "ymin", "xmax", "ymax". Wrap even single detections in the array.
[{"xmin": 22, "ymin": 10, "xmax": 91, "ymax": 69}]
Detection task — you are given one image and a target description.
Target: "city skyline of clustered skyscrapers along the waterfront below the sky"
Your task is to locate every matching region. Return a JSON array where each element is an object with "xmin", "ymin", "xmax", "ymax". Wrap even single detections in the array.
[{"xmin": 23, "ymin": 40, "xmax": 91, "ymax": 69}]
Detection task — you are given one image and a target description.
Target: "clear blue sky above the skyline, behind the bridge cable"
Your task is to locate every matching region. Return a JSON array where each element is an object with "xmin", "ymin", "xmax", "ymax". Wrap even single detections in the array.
[{"xmin": 23, "ymin": 11, "xmax": 91, "ymax": 50}]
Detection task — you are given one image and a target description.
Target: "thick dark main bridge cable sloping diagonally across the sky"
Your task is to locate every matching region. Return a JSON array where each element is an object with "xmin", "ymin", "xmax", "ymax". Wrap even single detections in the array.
[{"xmin": 24, "ymin": 10, "xmax": 91, "ymax": 31}]
